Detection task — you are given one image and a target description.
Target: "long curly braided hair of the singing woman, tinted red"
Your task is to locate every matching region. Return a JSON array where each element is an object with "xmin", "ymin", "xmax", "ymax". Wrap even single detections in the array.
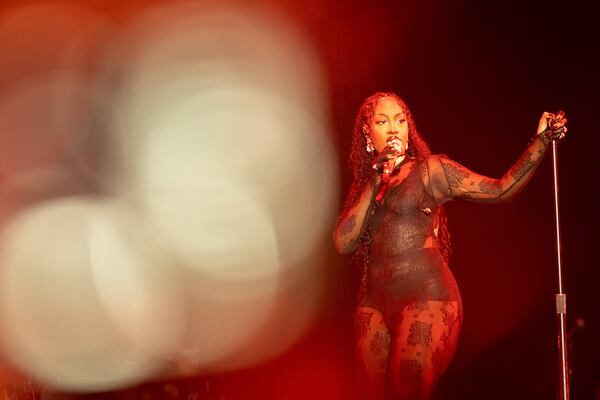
[{"xmin": 342, "ymin": 92, "xmax": 451, "ymax": 292}]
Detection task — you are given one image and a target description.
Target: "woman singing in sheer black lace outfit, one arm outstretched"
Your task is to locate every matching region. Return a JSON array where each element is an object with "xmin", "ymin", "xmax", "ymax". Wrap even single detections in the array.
[{"xmin": 334, "ymin": 93, "xmax": 567, "ymax": 400}]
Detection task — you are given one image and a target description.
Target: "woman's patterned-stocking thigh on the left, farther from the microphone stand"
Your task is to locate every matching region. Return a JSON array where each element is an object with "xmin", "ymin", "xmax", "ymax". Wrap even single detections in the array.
[{"xmin": 354, "ymin": 307, "xmax": 390, "ymax": 400}]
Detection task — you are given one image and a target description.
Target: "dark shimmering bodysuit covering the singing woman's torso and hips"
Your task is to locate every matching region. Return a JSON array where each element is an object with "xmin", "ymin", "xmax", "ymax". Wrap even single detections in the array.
[{"xmin": 360, "ymin": 161, "xmax": 460, "ymax": 326}]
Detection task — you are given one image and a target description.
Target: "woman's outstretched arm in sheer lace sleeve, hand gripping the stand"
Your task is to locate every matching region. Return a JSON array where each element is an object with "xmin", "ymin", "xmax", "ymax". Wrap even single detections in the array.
[{"xmin": 429, "ymin": 112, "xmax": 567, "ymax": 203}]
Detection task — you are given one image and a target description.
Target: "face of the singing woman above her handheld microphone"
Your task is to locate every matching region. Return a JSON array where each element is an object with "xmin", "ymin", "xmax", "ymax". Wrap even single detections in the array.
[{"xmin": 368, "ymin": 97, "xmax": 408, "ymax": 153}]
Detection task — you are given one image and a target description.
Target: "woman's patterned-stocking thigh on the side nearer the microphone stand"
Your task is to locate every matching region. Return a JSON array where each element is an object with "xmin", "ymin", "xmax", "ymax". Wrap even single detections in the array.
[{"xmin": 388, "ymin": 301, "xmax": 462, "ymax": 399}]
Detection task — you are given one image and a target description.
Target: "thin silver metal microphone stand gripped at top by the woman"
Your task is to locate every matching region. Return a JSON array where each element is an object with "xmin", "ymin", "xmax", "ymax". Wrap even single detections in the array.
[{"xmin": 552, "ymin": 140, "xmax": 569, "ymax": 400}]
